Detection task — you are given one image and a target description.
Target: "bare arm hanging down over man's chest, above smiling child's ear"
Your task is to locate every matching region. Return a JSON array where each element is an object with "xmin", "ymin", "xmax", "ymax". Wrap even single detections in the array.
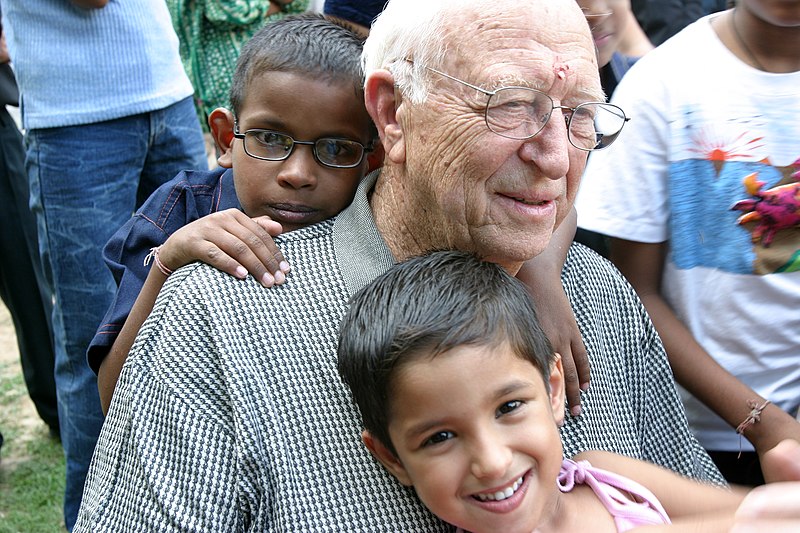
[{"xmin": 517, "ymin": 207, "xmax": 589, "ymax": 416}]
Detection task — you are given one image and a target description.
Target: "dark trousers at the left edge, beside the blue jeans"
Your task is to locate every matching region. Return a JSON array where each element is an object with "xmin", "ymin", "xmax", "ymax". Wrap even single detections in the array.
[{"xmin": 0, "ymin": 106, "xmax": 59, "ymax": 435}]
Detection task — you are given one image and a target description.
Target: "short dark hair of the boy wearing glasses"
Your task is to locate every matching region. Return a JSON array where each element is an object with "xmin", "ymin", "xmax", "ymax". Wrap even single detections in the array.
[{"xmin": 230, "ymin": 13, "xmax": 364, "ymax": 116}]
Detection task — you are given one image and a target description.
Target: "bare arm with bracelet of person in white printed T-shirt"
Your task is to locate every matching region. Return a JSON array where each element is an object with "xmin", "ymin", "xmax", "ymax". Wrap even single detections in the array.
[{"xmin": 611, "ymin": 239, "xmax": 800, "ymax": 472}]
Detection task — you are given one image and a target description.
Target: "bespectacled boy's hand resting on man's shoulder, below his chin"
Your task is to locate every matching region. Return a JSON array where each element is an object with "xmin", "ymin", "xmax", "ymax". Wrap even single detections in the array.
[{"xmin": 159, "ymin": 209, "xmax": 289, "ymax": 287}]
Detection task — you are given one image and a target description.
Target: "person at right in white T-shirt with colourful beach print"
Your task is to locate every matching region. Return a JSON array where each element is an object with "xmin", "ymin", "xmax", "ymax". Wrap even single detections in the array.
[{"xmin": 577, "ymin": 0, "xmax": 800, "ymax": 484}]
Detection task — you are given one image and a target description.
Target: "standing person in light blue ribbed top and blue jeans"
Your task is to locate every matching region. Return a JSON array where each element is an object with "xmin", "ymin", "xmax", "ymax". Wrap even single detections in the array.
[{"xmin": 3, "ymin": 0, "xmax": 207, "ymax": 529}]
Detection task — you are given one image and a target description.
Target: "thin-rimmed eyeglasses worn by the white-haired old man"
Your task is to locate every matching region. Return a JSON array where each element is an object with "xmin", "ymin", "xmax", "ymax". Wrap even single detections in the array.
[{"xmin": 406, "ymin": 59, "xmax": 630, "ymax": 152}]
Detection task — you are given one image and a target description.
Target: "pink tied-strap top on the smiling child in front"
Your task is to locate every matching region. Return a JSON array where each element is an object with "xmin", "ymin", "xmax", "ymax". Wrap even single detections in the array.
[{"xmin": 558, "ymin": 459, "xmax": 671, "ymax": 532}]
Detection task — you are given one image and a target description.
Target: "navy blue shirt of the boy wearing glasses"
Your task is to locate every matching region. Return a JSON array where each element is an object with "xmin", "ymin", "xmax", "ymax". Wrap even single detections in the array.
[{"xmin": 87, "ymin": 167, "xmax": 241, "ymax": 373}]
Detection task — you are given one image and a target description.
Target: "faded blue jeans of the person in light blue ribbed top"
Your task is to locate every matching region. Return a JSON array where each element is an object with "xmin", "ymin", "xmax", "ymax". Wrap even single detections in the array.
[{"xmin": 25, "ymin": 98, "xmax": 208, "ymax": 531}]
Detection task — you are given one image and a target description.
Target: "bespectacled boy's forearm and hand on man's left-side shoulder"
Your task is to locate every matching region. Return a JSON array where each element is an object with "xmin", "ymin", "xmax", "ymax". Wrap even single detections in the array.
[{"xmin": 97, "ymin": 209, "xmax": 289, "ymax": 413}]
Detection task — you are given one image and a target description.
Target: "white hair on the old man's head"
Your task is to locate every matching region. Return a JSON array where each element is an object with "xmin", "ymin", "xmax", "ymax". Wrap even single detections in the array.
[{"xmin": 361, "ymin": 0, "xmax": 489, "ymax": 104}]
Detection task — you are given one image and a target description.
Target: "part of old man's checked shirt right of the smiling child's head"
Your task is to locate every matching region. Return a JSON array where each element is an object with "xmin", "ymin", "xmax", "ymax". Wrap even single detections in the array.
[{"xmin": 561, "ymin": 243, "xmax": 725, "ymax": 485}]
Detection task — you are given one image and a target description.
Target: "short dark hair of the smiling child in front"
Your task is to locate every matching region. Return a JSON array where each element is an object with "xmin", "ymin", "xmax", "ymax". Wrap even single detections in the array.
[{"xmin": 338, "ymin": 251, "xmax": 554, "ymax": 453}]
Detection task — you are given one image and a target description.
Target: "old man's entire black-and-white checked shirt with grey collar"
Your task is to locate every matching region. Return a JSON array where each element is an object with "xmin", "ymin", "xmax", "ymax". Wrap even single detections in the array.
[{"xmin": 75, "ymin": 177, "xmax": 720, "ymax": 532}]
